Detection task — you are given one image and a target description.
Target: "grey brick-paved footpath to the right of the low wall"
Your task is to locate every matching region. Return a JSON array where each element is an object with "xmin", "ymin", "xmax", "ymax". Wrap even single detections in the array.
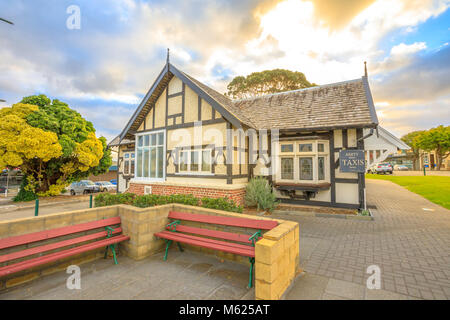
[{"xmin": 274, "ymin": 179, "xmax": 450, "ymax": 299}]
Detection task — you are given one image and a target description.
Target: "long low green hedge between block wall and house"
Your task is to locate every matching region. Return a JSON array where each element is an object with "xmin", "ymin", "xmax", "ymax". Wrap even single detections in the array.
[{"xmin": 95, "ymin": 193, "xmax": 242, "ymax": 213}]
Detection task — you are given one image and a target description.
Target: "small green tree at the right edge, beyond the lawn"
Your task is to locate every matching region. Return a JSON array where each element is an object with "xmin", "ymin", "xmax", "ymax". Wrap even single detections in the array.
[{"xmin": 416, "ymin": 125, "xmax": 450, "ymax": 171}]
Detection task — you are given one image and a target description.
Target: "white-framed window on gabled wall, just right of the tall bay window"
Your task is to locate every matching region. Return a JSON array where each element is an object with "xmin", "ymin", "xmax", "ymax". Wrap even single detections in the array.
[{"xmin": 179, "ymin": 149, "xmax": 212, "ymax": 174}]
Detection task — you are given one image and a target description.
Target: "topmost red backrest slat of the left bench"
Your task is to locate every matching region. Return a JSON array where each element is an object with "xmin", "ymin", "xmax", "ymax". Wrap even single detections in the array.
[{"xmin": 0, "ymin": 217, "xmax": 120, "ymax": 250}]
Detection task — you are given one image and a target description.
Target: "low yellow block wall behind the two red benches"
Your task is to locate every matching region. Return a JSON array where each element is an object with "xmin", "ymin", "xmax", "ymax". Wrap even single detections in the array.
[{"xmin": 0, "ymin": 204, "xmax": 299, "ymax": 299}]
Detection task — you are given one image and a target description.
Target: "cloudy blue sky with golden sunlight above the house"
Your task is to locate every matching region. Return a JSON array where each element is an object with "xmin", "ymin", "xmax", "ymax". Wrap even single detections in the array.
[{"xmin": 0, "ymin": 0, "xmax": 450, "ymax": 140}]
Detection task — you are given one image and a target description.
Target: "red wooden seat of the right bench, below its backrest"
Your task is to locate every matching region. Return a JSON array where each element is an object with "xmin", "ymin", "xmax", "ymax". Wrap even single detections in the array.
[{"xmin": 155, "ymin": 231, "xmax": 255, "ymax": 258}]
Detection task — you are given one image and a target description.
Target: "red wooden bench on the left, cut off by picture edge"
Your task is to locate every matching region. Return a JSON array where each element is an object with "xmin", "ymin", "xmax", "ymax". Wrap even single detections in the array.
[{"xmin": 0, "ymin": 217, "xmax": 130, "ymax": 277}]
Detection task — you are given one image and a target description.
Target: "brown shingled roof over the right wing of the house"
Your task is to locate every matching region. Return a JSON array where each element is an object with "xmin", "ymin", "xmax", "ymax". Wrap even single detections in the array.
[{"xmin": 234, "ymin": 77, "xmax": 378, "ymax": 130}]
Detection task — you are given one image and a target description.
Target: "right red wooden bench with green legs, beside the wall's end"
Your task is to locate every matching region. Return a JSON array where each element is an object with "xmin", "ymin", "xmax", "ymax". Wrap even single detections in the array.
[{"xmin": 155, "ymin": 212, "xmax": 278, "ymax": 288}]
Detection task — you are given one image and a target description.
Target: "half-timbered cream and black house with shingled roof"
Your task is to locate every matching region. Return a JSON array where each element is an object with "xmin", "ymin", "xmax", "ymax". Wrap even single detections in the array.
[{"xmin": 109, "ymin": 57, "xmax": 378, "ymax": 208}]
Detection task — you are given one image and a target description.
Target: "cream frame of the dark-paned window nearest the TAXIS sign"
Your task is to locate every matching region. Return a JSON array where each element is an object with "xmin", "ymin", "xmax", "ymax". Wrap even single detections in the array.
[{"xmin": 276, "ymin": 140, "xmax": 330, "ymax": 183}]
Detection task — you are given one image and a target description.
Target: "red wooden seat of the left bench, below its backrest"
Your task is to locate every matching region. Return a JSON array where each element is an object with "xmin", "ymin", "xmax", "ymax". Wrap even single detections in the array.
[{"xmin": 0, "ymin": 235, "xmax": 130, "ymax": 277}]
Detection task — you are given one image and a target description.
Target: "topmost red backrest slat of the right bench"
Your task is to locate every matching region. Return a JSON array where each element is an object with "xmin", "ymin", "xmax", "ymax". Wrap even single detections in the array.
[{"xmin": 169, "ymin": 211, "xmax": 278, "ymax": 230}]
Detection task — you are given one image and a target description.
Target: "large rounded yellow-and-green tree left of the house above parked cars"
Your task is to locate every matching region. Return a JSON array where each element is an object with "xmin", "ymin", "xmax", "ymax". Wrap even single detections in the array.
[{"xmin": 0, "ymin": 95, "xmax": 112, "ymax": 196}]
